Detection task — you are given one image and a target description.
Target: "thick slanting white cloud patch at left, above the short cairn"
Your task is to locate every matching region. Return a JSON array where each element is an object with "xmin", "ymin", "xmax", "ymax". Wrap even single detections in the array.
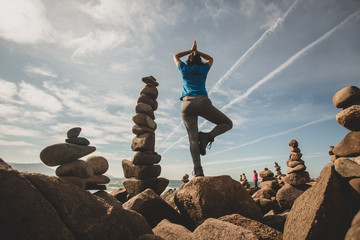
[{"xmin": 19, "ymin": 81, "xmax": 63, "ymax": 113}]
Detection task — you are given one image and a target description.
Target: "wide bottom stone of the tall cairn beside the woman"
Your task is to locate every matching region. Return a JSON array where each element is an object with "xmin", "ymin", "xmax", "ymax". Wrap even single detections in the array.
[{"xmin": 123, "ymin": 178, "xmax": 169, "ymax": 196}]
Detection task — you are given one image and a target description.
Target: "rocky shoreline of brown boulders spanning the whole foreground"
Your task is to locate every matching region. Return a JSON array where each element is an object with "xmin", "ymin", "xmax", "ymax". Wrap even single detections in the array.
[{"xmin": 0, "ymin": 87, "xmax": 360, "ymax": 240}]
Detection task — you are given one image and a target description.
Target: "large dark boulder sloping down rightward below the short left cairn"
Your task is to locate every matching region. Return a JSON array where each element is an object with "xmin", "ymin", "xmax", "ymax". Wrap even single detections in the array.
[{"xmin": 22, "ymin": 173, "xmax": 152, "ymax": 239}]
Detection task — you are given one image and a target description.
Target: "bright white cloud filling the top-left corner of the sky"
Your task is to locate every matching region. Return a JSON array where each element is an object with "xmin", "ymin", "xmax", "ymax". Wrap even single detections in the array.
[{"xmin": 0, "ymin": 0, "xmax": 52, "ymax": 43}]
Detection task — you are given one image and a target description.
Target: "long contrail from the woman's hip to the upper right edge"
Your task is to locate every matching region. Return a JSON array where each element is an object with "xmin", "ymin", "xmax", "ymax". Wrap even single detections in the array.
[{"xmin": 221, "ymin": 10, "xmax": 360, "ymax": 111}]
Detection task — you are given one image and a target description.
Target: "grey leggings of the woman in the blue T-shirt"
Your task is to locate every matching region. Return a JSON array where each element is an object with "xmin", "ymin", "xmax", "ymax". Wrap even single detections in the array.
[{"xmin": 181, "ymin": 95, "xmax": 233, "ymax": 168}]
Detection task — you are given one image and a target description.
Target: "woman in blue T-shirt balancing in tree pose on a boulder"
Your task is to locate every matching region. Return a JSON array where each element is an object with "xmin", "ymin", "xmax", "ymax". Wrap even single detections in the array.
[{"xmin": 174, "ymin": 41, "xmax": 232, "ymax": 177}]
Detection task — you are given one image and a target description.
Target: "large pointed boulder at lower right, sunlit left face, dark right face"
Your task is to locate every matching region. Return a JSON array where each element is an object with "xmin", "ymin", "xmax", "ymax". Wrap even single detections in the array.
[{"xmin": 284, "ymin": 163, "xmax": 354, "ymax": 240}]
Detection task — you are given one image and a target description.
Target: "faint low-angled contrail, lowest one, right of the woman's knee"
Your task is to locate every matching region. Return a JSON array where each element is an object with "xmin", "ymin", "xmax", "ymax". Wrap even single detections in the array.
[{"xmin": 209, "ymin": 115, "xmax": 335, "ymax": 157}]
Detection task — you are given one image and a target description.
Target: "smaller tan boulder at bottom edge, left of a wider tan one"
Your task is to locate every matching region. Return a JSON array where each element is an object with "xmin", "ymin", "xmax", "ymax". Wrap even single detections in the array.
[{"xmin": 153, "ymin": 219, "xmax": 195, "ymax": 240}]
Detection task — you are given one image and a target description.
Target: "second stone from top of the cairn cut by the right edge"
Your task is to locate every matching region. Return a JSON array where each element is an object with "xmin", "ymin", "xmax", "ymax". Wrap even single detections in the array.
[{"xmin": 336, "ymin": 105, "xmax": 360, "ymax": 131}]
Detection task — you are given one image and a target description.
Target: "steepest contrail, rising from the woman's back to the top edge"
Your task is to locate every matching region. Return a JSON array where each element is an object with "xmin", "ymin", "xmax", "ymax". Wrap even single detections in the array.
[{"xmin": 208, "ymin": 0, "xmax": 298, "ymax": 95}]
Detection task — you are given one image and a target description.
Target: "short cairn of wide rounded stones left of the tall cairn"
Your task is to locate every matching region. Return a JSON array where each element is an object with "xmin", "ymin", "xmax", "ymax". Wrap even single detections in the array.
[{"xmin": 40, "ymin": 127, "xmax": 110, "ymax": 190}]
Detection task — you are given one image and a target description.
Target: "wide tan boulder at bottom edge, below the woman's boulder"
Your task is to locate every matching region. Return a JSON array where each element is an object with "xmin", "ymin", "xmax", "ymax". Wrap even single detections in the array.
[{"xmin": 193, "ymin": 218, "xmax": 259, "ymax": 240}]
